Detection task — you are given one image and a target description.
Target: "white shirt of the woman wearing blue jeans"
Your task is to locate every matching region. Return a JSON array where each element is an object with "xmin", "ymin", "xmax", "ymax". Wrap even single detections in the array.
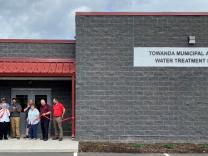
[{"xmin": 27, "ymin": 108, "xmax": 40, "ymax": 125}]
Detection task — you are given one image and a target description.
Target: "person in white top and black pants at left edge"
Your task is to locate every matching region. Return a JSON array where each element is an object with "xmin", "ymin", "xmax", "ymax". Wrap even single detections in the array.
[{"xmin": 0, "ymin": 103, "xmax": 10, "ymax": 140}]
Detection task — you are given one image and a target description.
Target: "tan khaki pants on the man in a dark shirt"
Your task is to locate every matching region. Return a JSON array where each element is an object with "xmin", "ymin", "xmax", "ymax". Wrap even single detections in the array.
[{"xmin": 11, "ymin": 117, "xmax": 20, "ymax": 138}]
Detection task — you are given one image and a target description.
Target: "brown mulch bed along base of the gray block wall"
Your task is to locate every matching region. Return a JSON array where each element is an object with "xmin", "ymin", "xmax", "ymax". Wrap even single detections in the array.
[{"xmin": 79, "ymin": 142, "xmax": 208, "ymax": 153}]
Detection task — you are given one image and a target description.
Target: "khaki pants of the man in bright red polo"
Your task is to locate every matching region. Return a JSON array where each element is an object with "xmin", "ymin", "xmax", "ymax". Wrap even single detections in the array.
[{"xmin": 53, "ymin": 117, "xmax": 63, "ymax": 138}]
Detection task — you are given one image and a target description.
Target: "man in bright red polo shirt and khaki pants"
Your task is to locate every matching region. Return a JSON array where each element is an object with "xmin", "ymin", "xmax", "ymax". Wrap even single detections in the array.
[{"xmin": 53, "ymin": 98, "xmax": 65, "ymax": 141}]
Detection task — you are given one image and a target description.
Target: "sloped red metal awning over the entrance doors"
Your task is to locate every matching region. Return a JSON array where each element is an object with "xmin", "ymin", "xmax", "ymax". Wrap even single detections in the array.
[{"xmin": 0, "ymin": 58, "xmax": 75, "ymax": 77}]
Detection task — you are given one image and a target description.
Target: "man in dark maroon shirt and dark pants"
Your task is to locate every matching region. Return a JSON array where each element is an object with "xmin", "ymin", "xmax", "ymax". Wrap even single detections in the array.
[{"xmin": 40, "ymin": 99, "xmax": 51, "ymax": 141}]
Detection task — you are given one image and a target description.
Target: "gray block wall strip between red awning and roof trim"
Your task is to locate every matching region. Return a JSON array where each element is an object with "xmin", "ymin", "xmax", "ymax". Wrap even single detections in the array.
[{"xmin": 0, "ymin": 43, "xmax": 75, "ymax": 58}]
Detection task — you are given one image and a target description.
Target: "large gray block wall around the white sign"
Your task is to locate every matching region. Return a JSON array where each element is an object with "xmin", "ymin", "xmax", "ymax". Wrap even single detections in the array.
[{"xmin": 76, "ymin": 16, "xmax": 208, "ymax": 143}]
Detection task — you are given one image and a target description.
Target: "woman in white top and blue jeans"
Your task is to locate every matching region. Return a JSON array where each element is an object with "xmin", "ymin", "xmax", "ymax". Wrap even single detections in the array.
[{"xmin": 27, "ymin": 103, "xmax": 40, "ymax": 139}]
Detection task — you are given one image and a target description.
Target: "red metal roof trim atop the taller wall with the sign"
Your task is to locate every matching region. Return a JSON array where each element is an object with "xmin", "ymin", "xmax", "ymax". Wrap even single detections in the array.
[{"xmin": 76, "ymin": 12, "xmax": 208, "ymax": 16}]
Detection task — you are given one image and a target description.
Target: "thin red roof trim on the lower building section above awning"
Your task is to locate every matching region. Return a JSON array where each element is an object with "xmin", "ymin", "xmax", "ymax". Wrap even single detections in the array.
[{"xmin": 0, "ymin": 39, "xmax": 76, "ymax": 44}]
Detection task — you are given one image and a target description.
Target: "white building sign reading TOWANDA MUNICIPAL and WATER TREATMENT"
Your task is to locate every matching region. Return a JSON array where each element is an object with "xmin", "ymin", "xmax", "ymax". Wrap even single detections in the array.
[{"xmin": 134, "ymin": 47, "xmax": 208, "ymax": 67}]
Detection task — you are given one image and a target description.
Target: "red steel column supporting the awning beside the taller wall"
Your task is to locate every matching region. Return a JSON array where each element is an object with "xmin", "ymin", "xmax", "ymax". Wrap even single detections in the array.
[{"xmin": 71, "ymin": 73, "xmax": 75, "ymax": 139}]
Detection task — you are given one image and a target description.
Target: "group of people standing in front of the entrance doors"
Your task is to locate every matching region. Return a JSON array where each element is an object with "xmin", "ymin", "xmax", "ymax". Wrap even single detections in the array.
[{"xmin": 0, "ymin": 98, "xmax": 65, "ymax": 141}]
